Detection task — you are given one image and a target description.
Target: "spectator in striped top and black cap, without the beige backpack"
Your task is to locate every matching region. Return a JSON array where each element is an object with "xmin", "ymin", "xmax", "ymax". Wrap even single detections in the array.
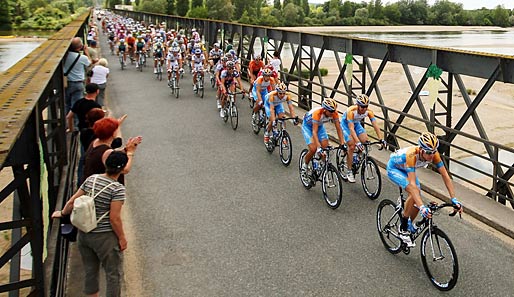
[{"xmin": 52, "ymin": 151, "xmax": 133, "ymax": 297}]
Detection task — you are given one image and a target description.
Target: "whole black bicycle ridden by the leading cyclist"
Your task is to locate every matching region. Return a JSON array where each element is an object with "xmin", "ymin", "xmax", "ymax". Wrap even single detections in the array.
[{"xmin": 377, "ymin": 188, "xmax": 459, "ymax": 291}]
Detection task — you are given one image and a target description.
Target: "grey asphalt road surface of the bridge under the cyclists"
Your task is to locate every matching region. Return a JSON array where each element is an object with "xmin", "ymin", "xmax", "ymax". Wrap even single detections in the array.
[{"xmin": 97, "ymin": 34, "xmax": 514, "ymax": 297}]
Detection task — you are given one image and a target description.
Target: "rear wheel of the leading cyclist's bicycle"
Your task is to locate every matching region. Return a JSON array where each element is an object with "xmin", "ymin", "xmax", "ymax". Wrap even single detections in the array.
[{"xmin": 377, "ymin": 199, "xmax": 402, "ymax": 254}]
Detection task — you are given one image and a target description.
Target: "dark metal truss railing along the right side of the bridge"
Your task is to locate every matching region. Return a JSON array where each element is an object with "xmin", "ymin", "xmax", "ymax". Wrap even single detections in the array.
[{"xmin": 114, "ymin": 10, "xmax": 514, "ymax": 207}]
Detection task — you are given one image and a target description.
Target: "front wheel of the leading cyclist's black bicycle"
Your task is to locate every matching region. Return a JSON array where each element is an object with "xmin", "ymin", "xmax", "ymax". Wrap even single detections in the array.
[{"xmin": 421, "ymin": 227, "xmax": 459, "ymax": 291}]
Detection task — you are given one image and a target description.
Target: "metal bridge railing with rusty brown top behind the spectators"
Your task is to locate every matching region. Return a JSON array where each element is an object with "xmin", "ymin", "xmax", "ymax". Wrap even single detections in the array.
[{"xmin": 0, "ymin": 12, "xmax": 89, "ymax": 297}]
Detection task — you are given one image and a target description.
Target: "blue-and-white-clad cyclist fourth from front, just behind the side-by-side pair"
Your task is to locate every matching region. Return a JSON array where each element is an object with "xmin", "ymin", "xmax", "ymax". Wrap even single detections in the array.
[{"xmin": 264, "ymin": 83, "xmax": 298, "ymax": 143}]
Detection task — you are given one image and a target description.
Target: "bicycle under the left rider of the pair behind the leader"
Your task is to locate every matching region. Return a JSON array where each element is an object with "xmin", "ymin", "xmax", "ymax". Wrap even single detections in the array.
[{"xmin": 298, "ymin": 146, "xmax": 343, "ymax": 209}]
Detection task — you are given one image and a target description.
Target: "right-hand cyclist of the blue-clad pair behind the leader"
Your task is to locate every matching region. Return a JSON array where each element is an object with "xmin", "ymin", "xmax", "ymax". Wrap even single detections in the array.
[{"xmin": 341, "ymin": 94, "xmax": 386, "ymax": 183}]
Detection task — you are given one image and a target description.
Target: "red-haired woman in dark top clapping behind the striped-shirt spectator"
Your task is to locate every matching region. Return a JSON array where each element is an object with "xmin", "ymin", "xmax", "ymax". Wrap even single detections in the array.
[{"xmin": 80, "ymin": 115, "xmax": 142, "ymax": 183}]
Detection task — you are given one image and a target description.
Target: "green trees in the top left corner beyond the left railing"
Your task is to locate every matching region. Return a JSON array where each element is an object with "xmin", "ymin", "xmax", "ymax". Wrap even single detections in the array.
[{"xmin": 0, "ymin": 0, "xmax": 93, "ymax": 31}]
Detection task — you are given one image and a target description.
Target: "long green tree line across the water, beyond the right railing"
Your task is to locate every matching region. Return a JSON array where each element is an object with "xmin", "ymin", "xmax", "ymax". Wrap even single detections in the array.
[{"xmin": 113, "ymin": 0, "xmax": 514, "ymax": 27}]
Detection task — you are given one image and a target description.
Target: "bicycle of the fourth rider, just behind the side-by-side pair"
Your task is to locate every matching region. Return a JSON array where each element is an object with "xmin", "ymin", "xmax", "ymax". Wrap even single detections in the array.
[{"xmin": 264, "ymin": 117, "xmax": 298, "ymax": 166}]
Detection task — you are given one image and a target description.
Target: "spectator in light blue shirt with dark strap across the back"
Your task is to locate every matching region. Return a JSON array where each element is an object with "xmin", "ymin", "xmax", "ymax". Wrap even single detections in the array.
[{"xmin": 63, "ymin": 37, "xmax": 91, "ymax": 114}]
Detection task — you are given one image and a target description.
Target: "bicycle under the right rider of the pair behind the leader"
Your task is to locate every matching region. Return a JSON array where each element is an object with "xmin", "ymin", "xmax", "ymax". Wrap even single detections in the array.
[{"xmin": 336, "ymin": 141, "xmax": 384, "ymax": 200}]
